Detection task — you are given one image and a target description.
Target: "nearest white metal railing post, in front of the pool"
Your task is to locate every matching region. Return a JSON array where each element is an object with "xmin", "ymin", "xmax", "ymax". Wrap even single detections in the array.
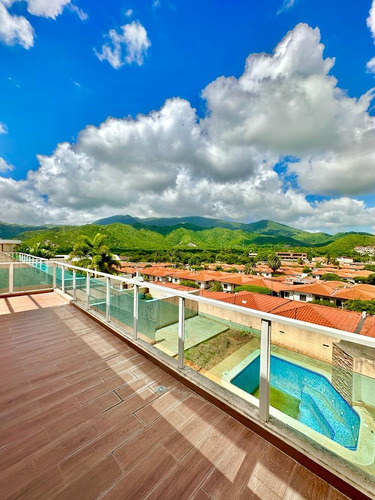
[{"xmin": 259, "ymin": 319, "xmax": 271, "ymax": 422}]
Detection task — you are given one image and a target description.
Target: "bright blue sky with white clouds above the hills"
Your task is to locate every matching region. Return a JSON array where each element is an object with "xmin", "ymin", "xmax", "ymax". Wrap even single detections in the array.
[{"xmin": 0, "ymin": 0, "xmax": 375, "ymax": 233}]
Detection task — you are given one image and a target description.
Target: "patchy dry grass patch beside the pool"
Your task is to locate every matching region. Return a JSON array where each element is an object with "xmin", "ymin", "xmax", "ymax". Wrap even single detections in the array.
[{"xmin": 185, "ymin": 329, "xmax": 254, "ymax": 370}]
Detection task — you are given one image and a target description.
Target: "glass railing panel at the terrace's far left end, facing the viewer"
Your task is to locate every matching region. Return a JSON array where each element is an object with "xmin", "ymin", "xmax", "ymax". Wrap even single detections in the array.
[{"xmin": 13, "ymin": 262, "xmax": 53, "ymax": 292}]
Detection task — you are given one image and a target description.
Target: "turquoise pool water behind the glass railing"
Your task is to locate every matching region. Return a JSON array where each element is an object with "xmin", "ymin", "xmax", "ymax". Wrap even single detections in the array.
[{"xmin": 231, "ymin": 356, "xmax": 360, "ymax": 450}]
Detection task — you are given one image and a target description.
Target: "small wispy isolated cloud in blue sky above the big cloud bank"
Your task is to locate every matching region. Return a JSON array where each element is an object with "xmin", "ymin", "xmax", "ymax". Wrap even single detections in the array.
[{"xmin": 95, "ymin": 21, "xmax": 151, "ymax": 69}]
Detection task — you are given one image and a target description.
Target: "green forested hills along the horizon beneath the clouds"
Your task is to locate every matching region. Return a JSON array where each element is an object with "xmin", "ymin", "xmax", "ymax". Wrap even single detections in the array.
[{"xmin": 0, "ymin": 215, "xmax": 375, "ymax": 257}]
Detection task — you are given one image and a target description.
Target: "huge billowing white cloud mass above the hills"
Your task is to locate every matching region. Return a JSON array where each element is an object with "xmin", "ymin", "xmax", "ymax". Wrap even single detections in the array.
[{"xmin": 0, "ymin": 24, "xmax": 375, "ymax": 231}]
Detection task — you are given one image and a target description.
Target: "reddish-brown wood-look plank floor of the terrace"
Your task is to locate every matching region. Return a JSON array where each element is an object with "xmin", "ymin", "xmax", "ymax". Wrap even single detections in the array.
[{"xmin": 0, "ymin": 293, "xmax": 352, "ymax": 500}]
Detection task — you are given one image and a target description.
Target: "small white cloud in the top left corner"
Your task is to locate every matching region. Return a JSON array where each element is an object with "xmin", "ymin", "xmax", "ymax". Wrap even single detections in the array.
[{"xmin": 0, "ymin": 2, "xmax": 34, "ymax": 49}]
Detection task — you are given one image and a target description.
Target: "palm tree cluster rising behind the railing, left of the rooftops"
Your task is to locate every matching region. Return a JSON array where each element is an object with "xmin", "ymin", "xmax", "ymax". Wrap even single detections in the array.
[{"xmin": 69, "ymin": 233, "xmax": 120, "ymax": 274}]
